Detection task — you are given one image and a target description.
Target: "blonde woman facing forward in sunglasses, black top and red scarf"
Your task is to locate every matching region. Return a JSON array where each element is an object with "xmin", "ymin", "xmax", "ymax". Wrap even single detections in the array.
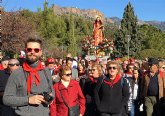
[{"xmin": 94, "ymin": 61, "xmax": 129, "ymax": 116}]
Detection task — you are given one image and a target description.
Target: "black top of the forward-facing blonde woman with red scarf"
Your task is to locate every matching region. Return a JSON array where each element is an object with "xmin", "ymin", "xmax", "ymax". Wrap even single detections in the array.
[{"xmin": 94, "ymin": 77, "xmax": 130, "ymax": 113}]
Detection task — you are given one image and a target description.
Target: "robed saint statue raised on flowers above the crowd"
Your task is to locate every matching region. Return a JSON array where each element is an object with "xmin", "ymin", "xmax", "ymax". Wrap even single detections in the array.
[{"xmin": 93, "ymin": 16, "xmax": 104, "ymax": 46}]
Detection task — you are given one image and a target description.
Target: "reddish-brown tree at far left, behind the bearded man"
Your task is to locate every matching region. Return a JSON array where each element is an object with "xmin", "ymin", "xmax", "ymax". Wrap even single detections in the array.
[{"xmin": 1, "ymin": 11, "xmax": 33, "ymax": 55}]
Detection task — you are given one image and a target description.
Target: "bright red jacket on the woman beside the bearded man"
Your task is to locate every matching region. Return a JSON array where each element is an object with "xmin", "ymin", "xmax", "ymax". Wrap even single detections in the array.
[{"xmin": 50, "ymin": 80, "xmax": 85, "ymax": 116}]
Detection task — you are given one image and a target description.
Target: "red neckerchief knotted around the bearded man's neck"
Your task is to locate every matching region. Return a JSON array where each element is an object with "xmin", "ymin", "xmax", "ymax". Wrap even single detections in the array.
[{"xmin": 23, "ymin": 62, "xmax": 43, "ymax": 93}]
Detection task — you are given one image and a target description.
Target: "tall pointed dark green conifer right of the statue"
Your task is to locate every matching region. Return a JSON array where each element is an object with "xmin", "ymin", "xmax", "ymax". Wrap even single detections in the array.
[{"xmin": 115, "ymin": 2, "xmax": 141, "ymax": 57}]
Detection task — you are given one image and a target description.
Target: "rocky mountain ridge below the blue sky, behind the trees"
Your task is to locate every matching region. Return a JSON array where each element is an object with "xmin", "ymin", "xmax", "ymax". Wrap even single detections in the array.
[{"xmin": 52, "ymin": 5, "xmax": 165, "ymax": 31}]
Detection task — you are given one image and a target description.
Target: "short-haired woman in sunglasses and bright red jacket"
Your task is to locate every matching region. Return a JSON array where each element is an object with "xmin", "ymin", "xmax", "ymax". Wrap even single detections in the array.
[{"xmin": 50, "ymin": 66, "xmax": 85, "ymax": 116}]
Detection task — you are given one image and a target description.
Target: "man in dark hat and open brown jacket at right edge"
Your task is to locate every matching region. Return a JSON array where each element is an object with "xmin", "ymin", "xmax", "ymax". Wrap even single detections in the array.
[{"xmin": 141, "ymin": 58, "xmax": 165, "ymax": 116}]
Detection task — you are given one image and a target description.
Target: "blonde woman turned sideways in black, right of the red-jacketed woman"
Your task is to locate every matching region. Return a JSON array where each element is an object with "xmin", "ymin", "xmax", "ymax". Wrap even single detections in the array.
[{"xmin": 80, "ymin": 64, "xmax": 103, "ymax": 116}]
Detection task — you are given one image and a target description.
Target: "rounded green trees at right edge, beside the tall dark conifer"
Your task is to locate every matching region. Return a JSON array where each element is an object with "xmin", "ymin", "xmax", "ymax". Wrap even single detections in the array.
[{"xmin": 138, "ymin": 24, "xmax": 165, "ymax": 58}]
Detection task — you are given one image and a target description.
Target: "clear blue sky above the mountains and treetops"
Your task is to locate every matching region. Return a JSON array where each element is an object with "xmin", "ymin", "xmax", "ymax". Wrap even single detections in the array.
[{"xmin": 1, "ymin": 0, "xmax": 165, "ymax": 21}]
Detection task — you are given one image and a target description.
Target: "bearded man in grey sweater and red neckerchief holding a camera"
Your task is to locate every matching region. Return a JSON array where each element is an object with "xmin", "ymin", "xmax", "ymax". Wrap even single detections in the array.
[{"xmin": 3, "ymin": 37, "xmax": 54, "ymax": 116}]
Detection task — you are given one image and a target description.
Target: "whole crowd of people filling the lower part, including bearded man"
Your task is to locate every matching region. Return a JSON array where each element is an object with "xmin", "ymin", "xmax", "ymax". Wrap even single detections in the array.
[{"xmin": 0, "ymin": 38, "xmax": 165, "ymax": 116}]
